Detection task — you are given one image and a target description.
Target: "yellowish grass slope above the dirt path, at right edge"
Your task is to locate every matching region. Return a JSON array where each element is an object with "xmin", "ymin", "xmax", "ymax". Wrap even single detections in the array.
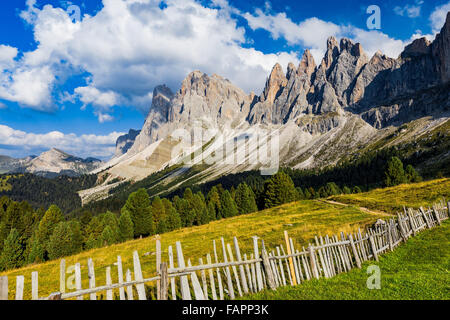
[{"xmin": 330, "ymin": 178, "xmax": 450, "ymax": 214}]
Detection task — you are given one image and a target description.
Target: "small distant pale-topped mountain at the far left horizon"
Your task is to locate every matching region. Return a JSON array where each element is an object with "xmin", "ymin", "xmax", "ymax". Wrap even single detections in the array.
[{"xmin": 0, "ymin": 148, "xmax": 103, "ymax": 178}]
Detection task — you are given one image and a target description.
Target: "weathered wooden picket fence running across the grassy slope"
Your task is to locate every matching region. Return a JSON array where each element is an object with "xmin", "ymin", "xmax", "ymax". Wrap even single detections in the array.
[{"xmin": 0, "ymin": 201, "xmax": 450, "ymax": 300}]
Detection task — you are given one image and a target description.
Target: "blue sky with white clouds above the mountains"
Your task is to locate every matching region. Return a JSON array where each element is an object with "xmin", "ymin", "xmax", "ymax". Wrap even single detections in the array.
[{"xmin": 0, "ymin": 0, "xmax": 450, "ymax": 159}]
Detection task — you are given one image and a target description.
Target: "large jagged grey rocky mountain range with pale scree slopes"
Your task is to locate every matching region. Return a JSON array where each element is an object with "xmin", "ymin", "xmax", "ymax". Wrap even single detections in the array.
[{"xmin": 78, "ymin": 13, "xmax": 450, "ymax": 200}]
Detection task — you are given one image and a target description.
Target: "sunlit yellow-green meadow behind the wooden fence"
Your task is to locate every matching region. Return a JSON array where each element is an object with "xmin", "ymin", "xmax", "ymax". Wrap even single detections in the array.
[{"xmin": 0, "ymin": 180, "xmax": 450, "ymax": 299}]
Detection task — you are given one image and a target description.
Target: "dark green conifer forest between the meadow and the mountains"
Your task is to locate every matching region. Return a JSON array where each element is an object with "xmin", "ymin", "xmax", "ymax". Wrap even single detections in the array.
[{"xmin": 0, "ymin": 156, "xmax": 422, "ymax": 270}]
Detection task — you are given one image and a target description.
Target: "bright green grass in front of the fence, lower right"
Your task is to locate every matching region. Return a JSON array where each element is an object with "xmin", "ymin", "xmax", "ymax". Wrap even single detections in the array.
[{"xmin": 246, "ymin": 220, "xmax": 450, "ymax": 300}]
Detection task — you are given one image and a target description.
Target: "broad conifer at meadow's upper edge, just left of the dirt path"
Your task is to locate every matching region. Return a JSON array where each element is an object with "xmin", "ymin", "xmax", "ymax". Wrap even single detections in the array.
[{"xmin": 264, "ymin": 172, "xmax": 297, "ymax": 208}]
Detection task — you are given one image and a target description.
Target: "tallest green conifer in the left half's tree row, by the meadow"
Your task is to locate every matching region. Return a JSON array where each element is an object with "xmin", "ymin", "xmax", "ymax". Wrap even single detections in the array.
[{"xmin": 122, "ymin": 188, "xmax": 154, "ymax": 238}]
